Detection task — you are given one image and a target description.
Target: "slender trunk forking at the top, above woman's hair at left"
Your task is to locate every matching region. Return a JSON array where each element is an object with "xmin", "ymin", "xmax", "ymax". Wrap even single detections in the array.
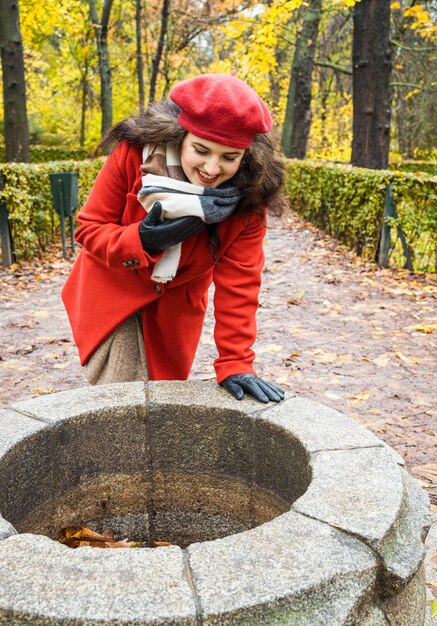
[{"xmin": 88, "ymin": 0, "xmax": 113, "ymax": 135}]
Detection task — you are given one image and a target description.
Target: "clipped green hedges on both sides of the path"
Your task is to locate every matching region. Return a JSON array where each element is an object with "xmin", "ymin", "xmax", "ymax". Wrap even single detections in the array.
[{"xmin": 0, "ymin": 158, "xmax": 437, "ymax": 271}]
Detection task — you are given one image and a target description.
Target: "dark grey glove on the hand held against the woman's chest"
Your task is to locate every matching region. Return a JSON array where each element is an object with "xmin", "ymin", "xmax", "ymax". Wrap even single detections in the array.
[{"xmin": 139, "ymin": 202, "xmax": 205, "ymax": 255}]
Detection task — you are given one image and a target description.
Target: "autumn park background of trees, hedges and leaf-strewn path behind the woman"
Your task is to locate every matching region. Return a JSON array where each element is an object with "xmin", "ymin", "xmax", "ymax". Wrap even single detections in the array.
[{"xmin": 0, "ymin": 0, "xmax": 437, "ymax": 619}]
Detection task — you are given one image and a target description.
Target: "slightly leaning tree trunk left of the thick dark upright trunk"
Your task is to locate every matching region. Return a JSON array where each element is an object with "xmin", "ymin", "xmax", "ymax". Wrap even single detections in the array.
[{"xmin": 282, "ymin": 0, "xmax": 322, "ymax": 159}]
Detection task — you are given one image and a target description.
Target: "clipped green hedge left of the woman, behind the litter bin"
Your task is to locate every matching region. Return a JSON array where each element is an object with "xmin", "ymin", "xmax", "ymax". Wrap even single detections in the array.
[{"xmin": 0, "ymin": 158, "xmax": 104, "ymax": 259}]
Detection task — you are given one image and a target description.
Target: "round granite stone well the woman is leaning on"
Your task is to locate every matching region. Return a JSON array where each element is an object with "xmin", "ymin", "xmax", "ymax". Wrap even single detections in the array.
[{"xmin": 0, "ymin": 382, "xmax": 430, "ymax": 626}]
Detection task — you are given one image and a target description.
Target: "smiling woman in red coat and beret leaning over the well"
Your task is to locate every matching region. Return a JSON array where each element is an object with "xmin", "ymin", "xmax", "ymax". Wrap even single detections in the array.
[{"xmin": 62, "ymin": 74, "xmax": 284, "ymax": 402}]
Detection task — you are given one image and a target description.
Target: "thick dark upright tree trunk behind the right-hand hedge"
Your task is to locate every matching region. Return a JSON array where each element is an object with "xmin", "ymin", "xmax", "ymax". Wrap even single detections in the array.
[{"xmin": 352, "ymin": 0, "xmax": 392, "ymax": 169}]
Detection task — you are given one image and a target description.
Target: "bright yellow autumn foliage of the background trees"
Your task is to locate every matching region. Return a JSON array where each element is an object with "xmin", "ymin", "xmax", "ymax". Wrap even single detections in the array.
[{"xmin": 11, "ymin": 0, "xmax": 368, "ymax": 155}]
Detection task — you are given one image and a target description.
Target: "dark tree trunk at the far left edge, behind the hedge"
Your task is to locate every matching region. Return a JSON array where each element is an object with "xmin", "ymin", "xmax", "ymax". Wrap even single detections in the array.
[{"xmin": 0, "ymin": 0, "xmax": 30, "ymax": 162}]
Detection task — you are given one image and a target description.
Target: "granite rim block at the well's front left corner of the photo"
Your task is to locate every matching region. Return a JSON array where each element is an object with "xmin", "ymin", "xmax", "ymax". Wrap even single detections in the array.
[{"xmin": 0, "ymin": 534, "xmax": 197, "ymax": 626}]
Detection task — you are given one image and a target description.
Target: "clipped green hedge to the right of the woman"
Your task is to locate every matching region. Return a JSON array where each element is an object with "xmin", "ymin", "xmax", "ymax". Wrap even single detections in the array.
[{"xmin": 285, "ymin": 159, "xmax": 437, "ymax": 271}]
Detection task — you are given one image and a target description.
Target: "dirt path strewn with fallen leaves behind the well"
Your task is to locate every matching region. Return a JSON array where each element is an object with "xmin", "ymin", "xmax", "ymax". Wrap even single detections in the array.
[{"xmin": 0, "ymin": 216, "xmax": 437, "ymax": 504}]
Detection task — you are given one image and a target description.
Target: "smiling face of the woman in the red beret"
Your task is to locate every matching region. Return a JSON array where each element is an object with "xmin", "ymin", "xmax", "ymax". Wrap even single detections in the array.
[{"xmin": 181, "ymin": 133, "xmax": 244, "ymax": 187}]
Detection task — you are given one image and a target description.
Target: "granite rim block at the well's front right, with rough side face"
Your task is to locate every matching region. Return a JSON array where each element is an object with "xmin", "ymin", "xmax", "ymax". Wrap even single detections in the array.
[{"xmin": 187, "ymin": 512, "xmax": 378, "ymax": 626}]
